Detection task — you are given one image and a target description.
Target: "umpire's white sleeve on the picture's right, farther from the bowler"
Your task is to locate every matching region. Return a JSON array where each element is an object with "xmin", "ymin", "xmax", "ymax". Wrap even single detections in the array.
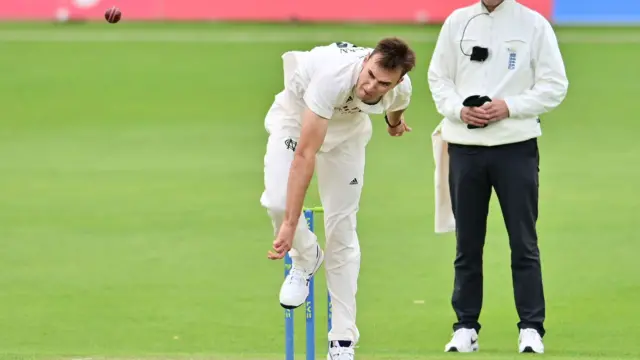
[{"xmin": 504, "ymin": 19, "xmax": 569, "ymax": 118}]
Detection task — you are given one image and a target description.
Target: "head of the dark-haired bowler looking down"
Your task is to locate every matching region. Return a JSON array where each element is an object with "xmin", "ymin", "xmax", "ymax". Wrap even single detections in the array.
[{"xmin": 356, "ymin": 38, "xmax": 416, "ymax": 104}]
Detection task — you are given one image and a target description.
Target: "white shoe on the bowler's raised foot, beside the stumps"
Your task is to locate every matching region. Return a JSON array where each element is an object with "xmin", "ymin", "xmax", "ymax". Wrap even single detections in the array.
[{"xmin": 280, "ymin": 245, "xmax": 324, "ymax": 309}]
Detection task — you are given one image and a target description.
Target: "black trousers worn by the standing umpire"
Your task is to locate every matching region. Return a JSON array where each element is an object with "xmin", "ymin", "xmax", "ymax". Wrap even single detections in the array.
[{"xmin": 449, "ymin": 138, "xmax": 545, "ymax": 336}]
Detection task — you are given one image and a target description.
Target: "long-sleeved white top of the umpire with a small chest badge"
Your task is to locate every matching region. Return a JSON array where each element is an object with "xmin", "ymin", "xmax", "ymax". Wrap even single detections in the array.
[{"xmin": 428, "ymin": 0, "xmax": 568, "ymax": 146}]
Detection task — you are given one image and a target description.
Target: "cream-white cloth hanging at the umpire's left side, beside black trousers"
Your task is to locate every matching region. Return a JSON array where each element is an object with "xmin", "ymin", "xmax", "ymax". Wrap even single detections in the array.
[{"xmin": 431, "ymin": 120, "xmax": 456, "ymax": 234}]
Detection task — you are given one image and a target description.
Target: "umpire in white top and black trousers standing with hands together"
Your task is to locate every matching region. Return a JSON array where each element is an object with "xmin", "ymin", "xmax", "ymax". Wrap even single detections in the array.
[{"xmin": 428, "ymin": 0, "xmax": 568, "ymax": 353}]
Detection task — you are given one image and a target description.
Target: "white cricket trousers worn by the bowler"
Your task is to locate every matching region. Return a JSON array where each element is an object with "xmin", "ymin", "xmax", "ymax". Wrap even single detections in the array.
[{"xmin": 261, "ymin": 129, "xmax": 371, "ymax": 342}]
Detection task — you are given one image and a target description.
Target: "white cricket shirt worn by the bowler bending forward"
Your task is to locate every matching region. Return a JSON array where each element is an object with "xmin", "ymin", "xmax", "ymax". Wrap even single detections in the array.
[{"xmin": 266, "ymin": 43, "xmax": 412, "ymax": 151}]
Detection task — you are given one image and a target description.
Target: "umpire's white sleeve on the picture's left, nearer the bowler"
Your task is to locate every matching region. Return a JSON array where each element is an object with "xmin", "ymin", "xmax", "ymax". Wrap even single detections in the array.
[{"xmin": 428, "ymin": 17, "xmax": 463, "ymax": 121}]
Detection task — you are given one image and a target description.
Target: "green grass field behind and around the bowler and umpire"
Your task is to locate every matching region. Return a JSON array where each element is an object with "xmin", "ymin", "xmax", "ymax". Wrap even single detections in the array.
[{"xmin": 0, "ymin": 23, "xmax": 640, "ymax": 360}]
